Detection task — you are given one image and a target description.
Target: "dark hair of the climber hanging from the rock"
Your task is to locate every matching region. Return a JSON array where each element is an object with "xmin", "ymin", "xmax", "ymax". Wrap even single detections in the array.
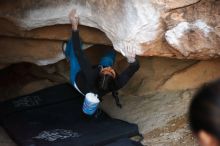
[{"xmin": 98, "ymin": 73, "xmax": 114, "ymax": 91}]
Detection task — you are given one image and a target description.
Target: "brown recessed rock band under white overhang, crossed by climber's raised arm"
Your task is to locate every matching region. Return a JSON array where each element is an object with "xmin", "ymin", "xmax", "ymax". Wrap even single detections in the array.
[{"xmin": 0, "ymin": 19, "xmax": 111, "ymax": 44}]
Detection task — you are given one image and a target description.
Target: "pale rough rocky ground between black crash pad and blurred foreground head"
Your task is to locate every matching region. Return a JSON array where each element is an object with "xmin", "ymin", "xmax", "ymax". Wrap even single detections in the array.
[{"xmin": 103, "ymin": 91, "xmax": 199, "ymax": 146}]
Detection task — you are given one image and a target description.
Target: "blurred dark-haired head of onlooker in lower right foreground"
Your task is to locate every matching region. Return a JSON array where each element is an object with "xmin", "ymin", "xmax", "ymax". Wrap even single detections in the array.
[{"xmin": 189, "ymin": 80, "xmax": 220, "ymax": 146}]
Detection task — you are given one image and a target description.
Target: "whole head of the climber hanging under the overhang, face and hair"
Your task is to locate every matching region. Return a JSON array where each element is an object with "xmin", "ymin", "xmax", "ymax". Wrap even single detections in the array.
[{"xmin": 98, "ymin": 67, "xmax": 116, "ymax": 91}]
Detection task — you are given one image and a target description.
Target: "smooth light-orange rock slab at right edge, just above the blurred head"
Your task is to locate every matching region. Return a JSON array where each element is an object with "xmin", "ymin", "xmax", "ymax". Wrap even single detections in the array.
[{"xmin": 160, "ymin": 59, "xmax": 220, "ymax": 90}]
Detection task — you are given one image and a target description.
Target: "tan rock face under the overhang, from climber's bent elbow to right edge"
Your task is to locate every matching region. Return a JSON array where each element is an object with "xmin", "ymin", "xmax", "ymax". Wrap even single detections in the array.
[{"xmin": 116, "ymin": 57, "xmax": 220, "ymax": 96}]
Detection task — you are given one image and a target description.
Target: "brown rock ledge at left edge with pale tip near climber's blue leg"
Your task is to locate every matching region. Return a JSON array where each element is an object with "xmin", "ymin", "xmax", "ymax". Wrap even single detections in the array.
[{"xmin": 0, "ymin": 37, "xmax": 64, "ymax": 65}]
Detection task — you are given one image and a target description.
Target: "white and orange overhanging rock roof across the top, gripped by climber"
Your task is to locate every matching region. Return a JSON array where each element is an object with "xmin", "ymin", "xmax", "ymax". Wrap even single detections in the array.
[{"xmin": 0, "ymin": 0, "xmax": 220, "ymax": 64}]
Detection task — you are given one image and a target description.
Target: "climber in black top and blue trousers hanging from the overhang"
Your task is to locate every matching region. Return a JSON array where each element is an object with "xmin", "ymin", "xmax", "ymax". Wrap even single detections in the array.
[{"xmin": 63, "ymin": 10, "xmax": 139, "ymax": 114}]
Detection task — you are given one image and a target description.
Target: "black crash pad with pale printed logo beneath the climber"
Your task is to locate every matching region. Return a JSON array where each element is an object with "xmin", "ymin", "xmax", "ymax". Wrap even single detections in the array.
[{"xmin": 0, "ymin": 84, "xmax": 139, "ymax": 146}]
